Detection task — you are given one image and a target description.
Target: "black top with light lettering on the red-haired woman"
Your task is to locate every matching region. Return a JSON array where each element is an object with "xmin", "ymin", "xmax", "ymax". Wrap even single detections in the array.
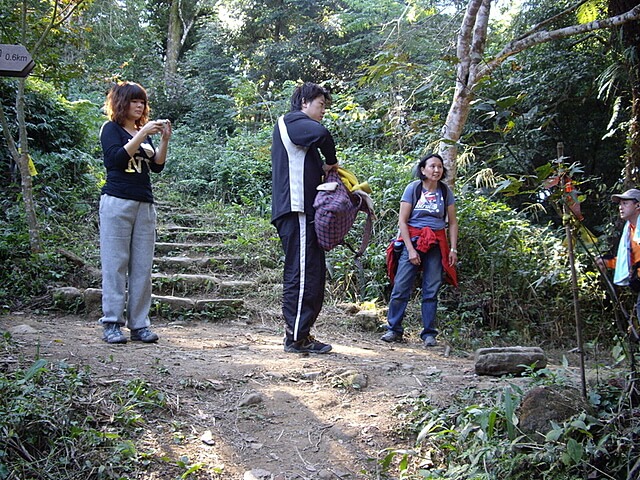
[{"xmin": 100, "ymin": 121, "xmax": 164, "ymax": 203}]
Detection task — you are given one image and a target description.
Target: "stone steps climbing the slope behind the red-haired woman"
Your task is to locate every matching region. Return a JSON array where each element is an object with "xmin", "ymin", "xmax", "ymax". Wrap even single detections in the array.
[{"xmin": 53, "ymin": 205, "xmax": 282, "ymax": 320}]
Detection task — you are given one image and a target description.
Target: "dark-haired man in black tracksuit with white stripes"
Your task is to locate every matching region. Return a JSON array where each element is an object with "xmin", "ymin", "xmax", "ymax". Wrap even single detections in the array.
[{"xmin": 271, "ymin": 83, "xmax": 338, "ymax": 353}]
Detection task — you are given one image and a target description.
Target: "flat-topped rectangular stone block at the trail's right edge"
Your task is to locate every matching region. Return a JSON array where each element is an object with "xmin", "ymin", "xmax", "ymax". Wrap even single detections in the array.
[{"xmin": 475, "ymin": 347, "xmax": 547, "ymax": 377}]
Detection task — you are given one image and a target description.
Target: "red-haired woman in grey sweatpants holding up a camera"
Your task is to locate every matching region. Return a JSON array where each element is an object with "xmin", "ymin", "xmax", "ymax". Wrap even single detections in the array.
[{"xmin": 100, "ymin": 82, "xmax": 171, "ymax": 343}]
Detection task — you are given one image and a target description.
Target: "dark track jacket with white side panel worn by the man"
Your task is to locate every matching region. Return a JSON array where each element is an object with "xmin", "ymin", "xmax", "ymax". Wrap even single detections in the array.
[{"xmin": 271, "ymin": 111, "xmax": 338, "ymax": 222}]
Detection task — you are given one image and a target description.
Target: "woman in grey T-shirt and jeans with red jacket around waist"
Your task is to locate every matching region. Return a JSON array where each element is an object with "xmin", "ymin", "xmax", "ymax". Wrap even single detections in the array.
[{"xmin": 380, "ymin": 154, "xmax": 458, "ymax": 347}]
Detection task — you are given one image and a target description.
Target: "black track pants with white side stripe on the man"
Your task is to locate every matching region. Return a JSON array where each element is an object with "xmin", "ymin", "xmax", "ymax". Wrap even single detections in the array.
[{"xmin": 273, "ymin": 212, "xmax": 327, "ymax": 342}]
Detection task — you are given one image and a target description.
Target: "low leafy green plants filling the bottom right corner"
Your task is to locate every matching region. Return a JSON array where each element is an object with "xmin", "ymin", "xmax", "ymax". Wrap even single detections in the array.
[{"xmin": 380, "ymin": 372, "xmax": 640, "ymax": 480}]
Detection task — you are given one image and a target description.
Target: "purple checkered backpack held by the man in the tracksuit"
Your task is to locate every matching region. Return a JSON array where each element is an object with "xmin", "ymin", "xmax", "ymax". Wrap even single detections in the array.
[{"xmin": 313, "ymin": 170, "xmax": 373, "ymax": 257}]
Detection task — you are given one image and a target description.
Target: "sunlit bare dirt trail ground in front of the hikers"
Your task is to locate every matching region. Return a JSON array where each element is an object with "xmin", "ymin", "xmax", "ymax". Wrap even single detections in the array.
[{"xmin": 0, "ymin": 307, "xmax": 536, "ymax": 480}]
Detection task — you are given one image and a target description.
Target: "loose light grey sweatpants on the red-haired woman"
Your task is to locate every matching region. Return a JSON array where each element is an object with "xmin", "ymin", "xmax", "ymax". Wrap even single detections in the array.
[{"xmin": 100, "ymin": 195, "xmax": 156, "ymax": 330}]
